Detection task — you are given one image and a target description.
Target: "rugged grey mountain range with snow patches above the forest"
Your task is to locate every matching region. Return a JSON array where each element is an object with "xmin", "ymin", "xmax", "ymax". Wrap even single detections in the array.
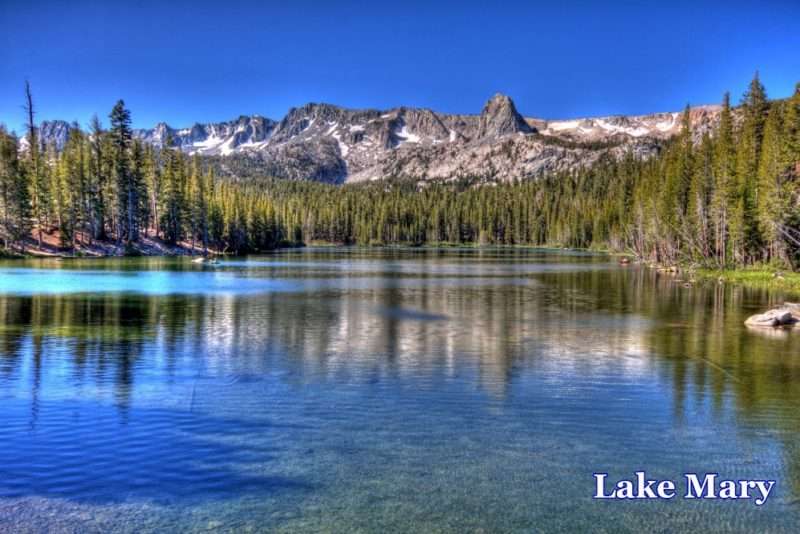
[{"xmin": 28, "ymin": 94, "xmax": 719, "ymax": 183}]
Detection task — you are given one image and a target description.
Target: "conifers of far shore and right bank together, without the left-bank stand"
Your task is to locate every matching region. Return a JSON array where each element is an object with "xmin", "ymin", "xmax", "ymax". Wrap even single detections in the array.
[{"xmin": 227, "ymin": 76, "xmax": 800, "ymax": 267}]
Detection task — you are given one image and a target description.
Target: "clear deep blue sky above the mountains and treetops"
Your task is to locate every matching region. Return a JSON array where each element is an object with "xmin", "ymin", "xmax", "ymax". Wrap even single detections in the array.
[{"xmin": 0, "ymin": 0, "xmax": 800, "ymax": 133}]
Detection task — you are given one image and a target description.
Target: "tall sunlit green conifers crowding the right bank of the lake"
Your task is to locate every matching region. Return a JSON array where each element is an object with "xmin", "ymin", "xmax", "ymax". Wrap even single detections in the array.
[{"xmin": 619, "ymin": 75, "xmax": 800, "ymax": 266}]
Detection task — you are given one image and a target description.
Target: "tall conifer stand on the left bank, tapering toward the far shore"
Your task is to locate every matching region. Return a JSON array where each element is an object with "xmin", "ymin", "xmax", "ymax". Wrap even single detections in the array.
[{"xmin": 0, "ymin": 93, "xmax": 281, "ymax": 253}]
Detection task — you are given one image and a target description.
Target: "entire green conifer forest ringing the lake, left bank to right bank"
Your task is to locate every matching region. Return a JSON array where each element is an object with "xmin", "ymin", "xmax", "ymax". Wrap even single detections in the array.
[{"xmin": 0, "ymin": 76, "xmax": 800, "ymax": 267}]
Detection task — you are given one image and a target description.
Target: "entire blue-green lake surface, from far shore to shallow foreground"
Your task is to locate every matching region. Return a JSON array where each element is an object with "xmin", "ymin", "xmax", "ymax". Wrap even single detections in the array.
[{"xmin": 0, "ymin": 249, "xmax": 800, "ymax": 532}]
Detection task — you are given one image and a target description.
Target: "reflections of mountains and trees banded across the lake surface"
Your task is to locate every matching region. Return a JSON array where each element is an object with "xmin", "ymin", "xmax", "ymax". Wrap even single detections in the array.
[{"xmin": 0, "ymin": 255, "xmax": 800, "ymax": 436}]
